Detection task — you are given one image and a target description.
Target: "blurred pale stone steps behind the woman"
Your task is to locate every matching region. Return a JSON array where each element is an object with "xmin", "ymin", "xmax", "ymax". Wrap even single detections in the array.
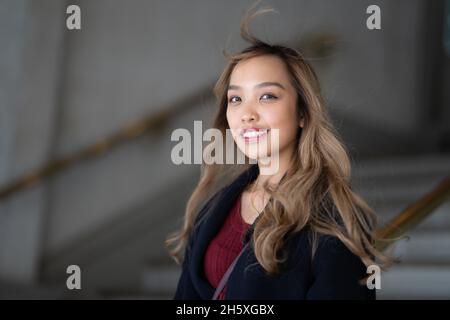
[{"xmin": 133, "ymin": 155, "xmax": 450, "ymax": 299}]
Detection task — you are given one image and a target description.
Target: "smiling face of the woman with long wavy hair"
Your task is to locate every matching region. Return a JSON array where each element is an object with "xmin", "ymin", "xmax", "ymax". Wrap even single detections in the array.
[{"xmin": 227, "ymin": 55, "xmax": 303, "ymax": 166}]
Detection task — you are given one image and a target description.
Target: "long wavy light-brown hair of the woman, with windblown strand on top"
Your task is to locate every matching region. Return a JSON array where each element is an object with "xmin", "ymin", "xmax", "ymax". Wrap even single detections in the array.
[{"xmin": 166, "ymin": 9, "xmax": 390, "ymax": 274}]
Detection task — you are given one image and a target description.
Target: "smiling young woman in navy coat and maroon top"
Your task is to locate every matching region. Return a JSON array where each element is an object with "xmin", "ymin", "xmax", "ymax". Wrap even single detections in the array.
[{"xmin": 167, "ymin": 8, "xmax": 387, "ymax": 299}]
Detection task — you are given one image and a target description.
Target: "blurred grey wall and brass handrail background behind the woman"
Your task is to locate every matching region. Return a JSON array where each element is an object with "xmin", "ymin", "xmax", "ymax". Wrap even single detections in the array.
[{"xmin": 0, "ymin": 0, "xmax": 450, "ymax": 299}]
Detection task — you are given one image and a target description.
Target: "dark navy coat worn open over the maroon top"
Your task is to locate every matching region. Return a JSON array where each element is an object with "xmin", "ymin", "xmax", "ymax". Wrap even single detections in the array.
[{"xmin": 174, "ymin": 165, "xmax": 375, "ymax": 300}]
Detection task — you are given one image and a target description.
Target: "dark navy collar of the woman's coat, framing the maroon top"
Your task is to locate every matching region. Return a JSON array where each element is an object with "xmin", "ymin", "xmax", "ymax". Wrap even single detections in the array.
[{"xmin": 189, "ymin": 164, "xmax": 259, "ymax": 299}]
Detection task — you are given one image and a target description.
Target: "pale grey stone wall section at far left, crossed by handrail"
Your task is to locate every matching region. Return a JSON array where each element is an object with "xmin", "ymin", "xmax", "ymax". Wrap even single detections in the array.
[{"xmin": 0, "ymin": 1, "xmax": 64, "ymax": 282}]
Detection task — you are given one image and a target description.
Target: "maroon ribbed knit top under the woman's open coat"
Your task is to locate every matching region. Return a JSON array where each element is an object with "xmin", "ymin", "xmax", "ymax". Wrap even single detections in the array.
[{"xmin": 204, "ymin": 192, "xmax": 251, "ymax": 300}]
